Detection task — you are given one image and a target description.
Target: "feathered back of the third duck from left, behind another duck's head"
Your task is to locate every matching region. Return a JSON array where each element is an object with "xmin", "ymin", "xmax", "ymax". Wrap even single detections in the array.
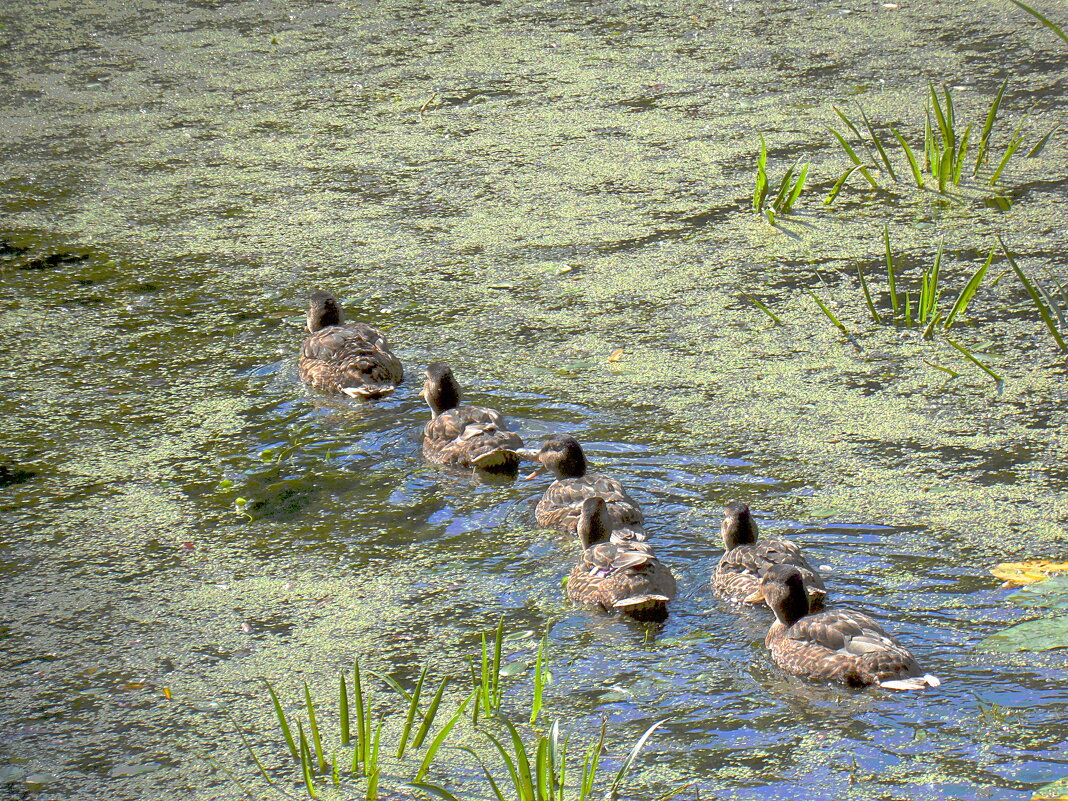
[{"xmin": 534, "ymin": 473, "xmax": 645, "ymax": 541}]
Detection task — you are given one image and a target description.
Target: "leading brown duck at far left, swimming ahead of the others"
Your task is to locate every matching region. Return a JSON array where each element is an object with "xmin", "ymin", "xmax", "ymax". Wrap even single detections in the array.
[{"xmin": 297, "ymin": 292, "xmax": 404, "ymax": 398}]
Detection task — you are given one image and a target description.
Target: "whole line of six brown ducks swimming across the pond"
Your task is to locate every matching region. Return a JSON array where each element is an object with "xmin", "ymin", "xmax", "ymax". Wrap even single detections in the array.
[{"xmin": 298, "ymin": 292, "xmax": 940, "ymax": 690}]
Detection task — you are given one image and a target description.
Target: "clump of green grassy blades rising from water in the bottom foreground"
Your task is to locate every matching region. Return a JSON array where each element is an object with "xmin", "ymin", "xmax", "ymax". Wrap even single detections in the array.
[{"xmin": 237, "ymin": 619, "xmax": 664, "ymax": 801}]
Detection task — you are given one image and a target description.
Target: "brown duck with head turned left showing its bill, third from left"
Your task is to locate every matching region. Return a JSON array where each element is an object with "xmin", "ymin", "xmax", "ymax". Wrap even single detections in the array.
[{"xmin": 519, "ymin": 434, "xmax": 647, "ymax": 543}]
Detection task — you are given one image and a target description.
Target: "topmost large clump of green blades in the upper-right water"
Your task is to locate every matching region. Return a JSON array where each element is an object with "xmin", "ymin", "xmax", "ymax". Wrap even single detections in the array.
[{"xmin": 823, "ymin": 79, "xmax": 1056, "ymax": 200}]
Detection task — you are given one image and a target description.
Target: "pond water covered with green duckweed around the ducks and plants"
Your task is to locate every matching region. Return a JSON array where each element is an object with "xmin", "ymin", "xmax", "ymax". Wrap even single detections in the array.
[{"xmin": 0, "ymin": 0, "xmax": 1068, "ymax": 800}]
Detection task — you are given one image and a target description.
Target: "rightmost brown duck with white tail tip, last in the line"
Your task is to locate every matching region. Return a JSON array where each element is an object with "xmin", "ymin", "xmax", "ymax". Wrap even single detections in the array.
[{"xmin": 747, "ymin": 565, "xmax": 942, "ymax": 690}]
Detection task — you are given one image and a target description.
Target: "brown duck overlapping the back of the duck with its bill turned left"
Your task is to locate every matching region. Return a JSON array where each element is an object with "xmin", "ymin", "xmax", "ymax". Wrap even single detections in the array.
[{"xmin": 567, "ymin": 497, "xmax": 675, "ymax": 621}]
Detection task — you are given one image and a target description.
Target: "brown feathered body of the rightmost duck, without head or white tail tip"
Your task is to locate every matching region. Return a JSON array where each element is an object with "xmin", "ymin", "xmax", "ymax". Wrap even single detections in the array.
[{"xmin": 766, "ymin": 610, "xmax": 921, "ymax": 687}]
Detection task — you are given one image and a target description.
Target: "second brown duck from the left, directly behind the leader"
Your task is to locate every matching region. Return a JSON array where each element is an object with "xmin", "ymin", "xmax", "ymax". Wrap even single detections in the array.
[{"xmin": 422, "ymin": 362, "xmax": 523, "ymax": 473}]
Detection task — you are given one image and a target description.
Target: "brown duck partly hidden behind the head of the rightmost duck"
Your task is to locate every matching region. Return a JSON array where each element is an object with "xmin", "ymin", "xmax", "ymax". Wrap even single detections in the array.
[{"xmin": 712, "ymin": 501, "xmax": 827, "ymax": 609}]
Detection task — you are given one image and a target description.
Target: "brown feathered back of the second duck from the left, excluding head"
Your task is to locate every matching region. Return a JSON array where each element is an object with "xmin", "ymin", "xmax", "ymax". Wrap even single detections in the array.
[{"xmin": 423, "ymin": 406, "xmax": 523, "ymax": 472}]
